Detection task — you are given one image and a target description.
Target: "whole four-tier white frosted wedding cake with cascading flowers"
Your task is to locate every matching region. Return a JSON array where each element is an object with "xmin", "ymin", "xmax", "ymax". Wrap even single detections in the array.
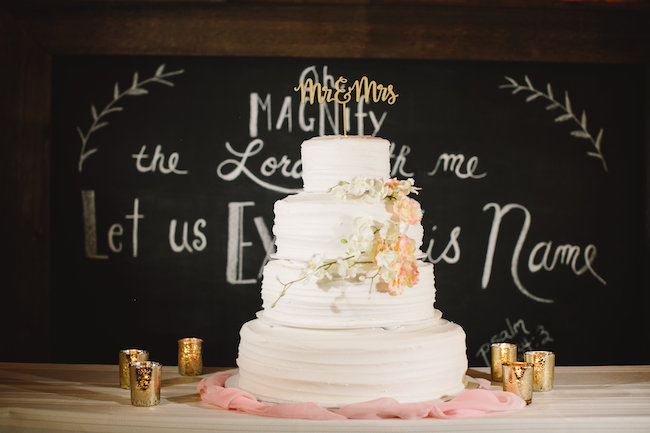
[{"xmin": 237, "ymin": 136, "xmax": 467, "ymax": 407}]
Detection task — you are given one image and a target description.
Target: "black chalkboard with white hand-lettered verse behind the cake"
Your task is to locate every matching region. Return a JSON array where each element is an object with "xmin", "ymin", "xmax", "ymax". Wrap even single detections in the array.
[{"xmin": 51, "ymin": 55, "xmax": 650, "ymax": 366}]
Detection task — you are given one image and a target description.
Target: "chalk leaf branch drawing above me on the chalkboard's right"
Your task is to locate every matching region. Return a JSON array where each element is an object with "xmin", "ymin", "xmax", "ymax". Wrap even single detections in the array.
[{"xmin": 499, "ymin": 75, "xmax": 607, "ymax": 171}]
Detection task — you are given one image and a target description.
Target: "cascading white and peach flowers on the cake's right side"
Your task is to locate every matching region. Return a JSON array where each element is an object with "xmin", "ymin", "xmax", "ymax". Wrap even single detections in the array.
[{"xmin": 273, "ymin": 178, "xmax": 422, "ymax": 306}]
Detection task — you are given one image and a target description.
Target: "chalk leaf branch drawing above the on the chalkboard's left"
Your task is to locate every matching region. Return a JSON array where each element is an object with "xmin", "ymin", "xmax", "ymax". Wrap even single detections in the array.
[{"xmin": 77, "ymin": 64, "xmax": 185, "ymax": 173}]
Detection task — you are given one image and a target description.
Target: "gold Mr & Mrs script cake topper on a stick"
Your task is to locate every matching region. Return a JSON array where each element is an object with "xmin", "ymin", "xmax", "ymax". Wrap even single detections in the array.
[{"xmin": 293, "ymin": 75, "xmax": 399, "ymax": 135}]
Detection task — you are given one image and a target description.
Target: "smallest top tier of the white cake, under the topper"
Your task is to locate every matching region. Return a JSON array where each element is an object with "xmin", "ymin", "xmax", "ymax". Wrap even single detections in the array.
[{"xmin": 301, "ymin": 135, "xmax": 390, "ymax": 192}]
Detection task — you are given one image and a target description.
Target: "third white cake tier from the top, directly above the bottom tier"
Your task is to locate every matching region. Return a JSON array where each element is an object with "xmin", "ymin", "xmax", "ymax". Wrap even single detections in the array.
[{"xmin": 262, "ymin": 260, "xmax": 440, "ymax": 329}]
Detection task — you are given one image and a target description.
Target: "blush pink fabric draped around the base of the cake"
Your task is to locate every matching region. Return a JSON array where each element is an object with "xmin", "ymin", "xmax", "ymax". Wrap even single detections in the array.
[{"xmin": 198, "ymin": 372, "xmax": 526, "ymax": 420}]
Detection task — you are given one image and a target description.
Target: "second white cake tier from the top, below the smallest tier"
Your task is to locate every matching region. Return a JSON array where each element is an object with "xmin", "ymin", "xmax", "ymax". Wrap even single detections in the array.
[{"xmin": 273, "ymin": 192, "xmax": 424, "ymax": 262}]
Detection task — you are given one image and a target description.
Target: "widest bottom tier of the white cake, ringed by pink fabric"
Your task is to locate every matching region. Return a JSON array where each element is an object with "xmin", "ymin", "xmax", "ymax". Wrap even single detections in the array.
[{"xmin": 237, "ymin": 315, "xmax": 467, "ymax": 407}]
